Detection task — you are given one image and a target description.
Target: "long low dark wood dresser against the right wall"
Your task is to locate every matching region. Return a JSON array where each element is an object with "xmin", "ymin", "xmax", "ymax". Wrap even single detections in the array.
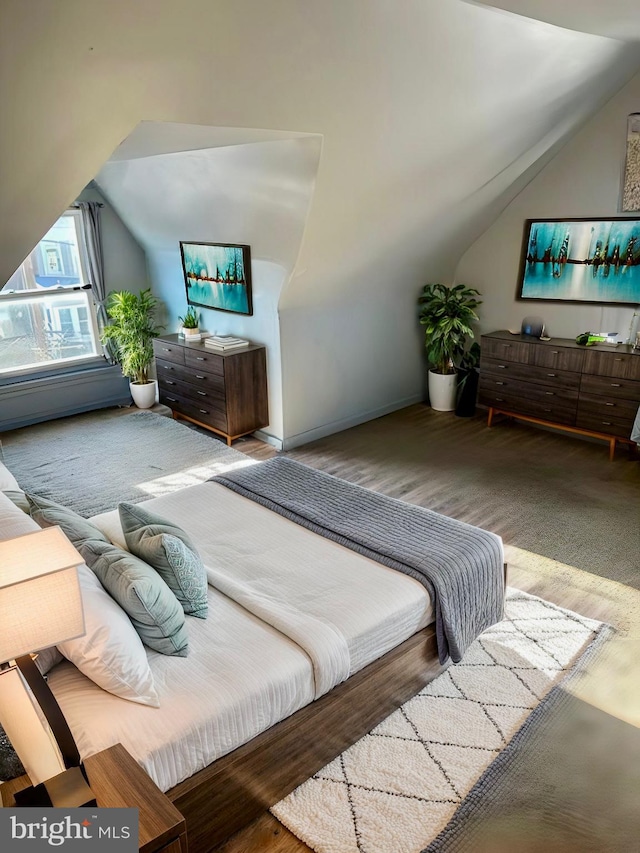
[{"xmin": 479, "ymin": 331, "xmax": 640, "ymax": 459}]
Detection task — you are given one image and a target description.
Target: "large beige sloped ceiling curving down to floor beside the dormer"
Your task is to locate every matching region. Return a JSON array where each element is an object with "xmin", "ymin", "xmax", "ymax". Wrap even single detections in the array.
[{"xmin": 0, "ymin": 0, "xmax": 640, "ymax": 441}]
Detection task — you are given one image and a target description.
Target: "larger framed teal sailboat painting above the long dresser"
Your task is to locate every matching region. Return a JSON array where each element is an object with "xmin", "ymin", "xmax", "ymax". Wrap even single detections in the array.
[{"xmin": 517, "ymin": 217, "xmax": 640, "ymax": 305}]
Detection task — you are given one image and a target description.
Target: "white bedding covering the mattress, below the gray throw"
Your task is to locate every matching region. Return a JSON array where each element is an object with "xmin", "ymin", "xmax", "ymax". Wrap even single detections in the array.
[{"xmin": 51, "ymin": 483, "xmax": 432, "ymax": 790}]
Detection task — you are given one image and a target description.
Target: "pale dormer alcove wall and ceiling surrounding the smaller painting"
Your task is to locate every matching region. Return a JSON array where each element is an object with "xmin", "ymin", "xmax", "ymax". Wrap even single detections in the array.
[{"xmin": 96, "ymin": 136, "xmax": 321, "ymax": 446}]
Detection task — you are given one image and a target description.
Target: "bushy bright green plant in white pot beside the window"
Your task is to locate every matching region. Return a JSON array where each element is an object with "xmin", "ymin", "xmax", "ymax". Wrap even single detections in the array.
[{"xmin": 101, "ymin": 288, "xmax": 162, "ymax": 409}]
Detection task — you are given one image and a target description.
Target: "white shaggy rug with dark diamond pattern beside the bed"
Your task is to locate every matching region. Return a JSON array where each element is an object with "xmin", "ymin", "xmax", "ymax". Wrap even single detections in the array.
[{"xmin": 271, "ymin": 589, "xmax": 602, "ymax": 853}]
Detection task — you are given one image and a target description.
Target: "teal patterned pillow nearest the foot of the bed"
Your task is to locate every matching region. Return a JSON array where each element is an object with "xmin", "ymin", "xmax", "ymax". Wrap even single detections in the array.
[{"xmin": 118, "ymin": 503, "xmax": 208, "ymax": 619}]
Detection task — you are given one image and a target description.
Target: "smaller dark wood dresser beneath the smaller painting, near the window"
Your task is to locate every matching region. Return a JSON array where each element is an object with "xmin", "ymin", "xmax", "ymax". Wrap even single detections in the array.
[{"xmin": 153, "ymin": 335, "xmax": 269, "ymax": 445}]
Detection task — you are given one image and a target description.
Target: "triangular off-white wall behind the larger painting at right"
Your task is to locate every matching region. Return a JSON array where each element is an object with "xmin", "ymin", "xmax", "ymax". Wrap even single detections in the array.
[{"xmin": 456, "ymin": 74, "xmax": 640, "ymax": 338}]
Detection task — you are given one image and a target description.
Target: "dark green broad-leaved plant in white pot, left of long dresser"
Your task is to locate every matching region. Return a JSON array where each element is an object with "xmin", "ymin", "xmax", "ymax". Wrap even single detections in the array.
[{"xmin": 418, "ymin": 284, "xmax": 481, "ymax": 412}]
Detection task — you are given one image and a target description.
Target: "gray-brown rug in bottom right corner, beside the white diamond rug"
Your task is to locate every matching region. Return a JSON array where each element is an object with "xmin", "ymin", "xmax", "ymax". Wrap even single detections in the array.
[{"xmin": 423, "ymin": 624, "xmax": 640, "ymax": 853}]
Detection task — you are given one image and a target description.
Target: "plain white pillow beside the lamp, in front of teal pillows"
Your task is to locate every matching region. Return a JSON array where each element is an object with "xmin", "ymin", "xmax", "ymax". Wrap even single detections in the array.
[{"xmin": 58, "ymin": 565, "xmax": 160, "ymax": 708}]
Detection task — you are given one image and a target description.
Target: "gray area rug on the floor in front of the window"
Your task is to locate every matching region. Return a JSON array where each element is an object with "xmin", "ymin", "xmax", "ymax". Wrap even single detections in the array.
[{"xmin": 2, "ymin": 411, "xmax": 253, "ymax": 517}]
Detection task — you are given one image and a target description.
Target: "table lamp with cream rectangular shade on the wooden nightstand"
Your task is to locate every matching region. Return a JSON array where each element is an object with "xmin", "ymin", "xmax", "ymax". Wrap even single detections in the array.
[{"xmin": 0, "ymin": 527, "xmax": 95, "ymax": 808}]
